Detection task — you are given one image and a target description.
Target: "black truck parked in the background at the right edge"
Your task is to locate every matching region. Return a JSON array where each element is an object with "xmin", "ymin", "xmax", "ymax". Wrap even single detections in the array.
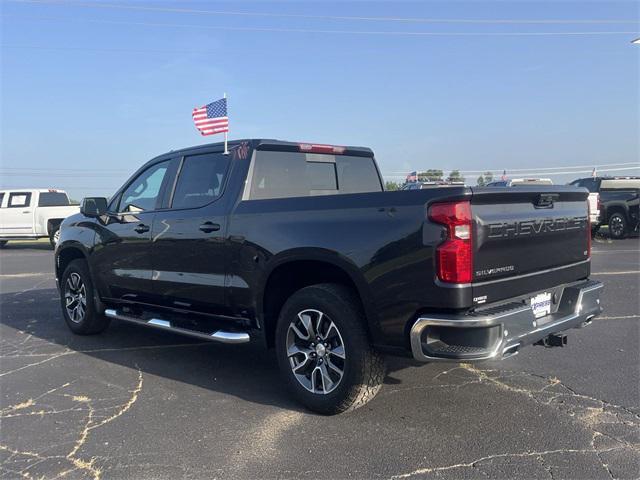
[{"xmin": 570, "ymin": 177, "xmax": 640, "ymax": 238}]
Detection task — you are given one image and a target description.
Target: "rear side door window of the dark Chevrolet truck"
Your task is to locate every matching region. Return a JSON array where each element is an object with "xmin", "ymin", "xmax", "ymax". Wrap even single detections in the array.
[{"xmin": 171, "ymin": 153, "xmax": 229, "ymax": 208}]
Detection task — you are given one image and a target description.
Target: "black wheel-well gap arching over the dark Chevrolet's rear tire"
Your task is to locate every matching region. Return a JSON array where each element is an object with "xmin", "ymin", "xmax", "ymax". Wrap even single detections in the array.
[{"xmin": 259, "ymin": 249, "xmax": 377, "ymax": 347}]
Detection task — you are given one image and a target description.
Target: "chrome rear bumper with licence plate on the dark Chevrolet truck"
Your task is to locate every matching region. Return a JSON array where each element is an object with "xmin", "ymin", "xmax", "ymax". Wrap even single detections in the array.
[{"xmin": 410, "ymin": 280, "xmax": 603, "ymax": 362}]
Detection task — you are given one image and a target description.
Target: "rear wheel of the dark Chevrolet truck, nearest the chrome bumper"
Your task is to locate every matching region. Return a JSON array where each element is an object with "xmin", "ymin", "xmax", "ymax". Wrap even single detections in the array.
[{"xmin": 276, "ymin": 284, "xmax": 386, "ymax": 415}]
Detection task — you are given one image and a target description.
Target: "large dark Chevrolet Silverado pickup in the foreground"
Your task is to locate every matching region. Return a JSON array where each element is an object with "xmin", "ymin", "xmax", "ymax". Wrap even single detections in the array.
[{"xmin": 55, "ymin": 140, "xmax": 602, "ymax": 414}]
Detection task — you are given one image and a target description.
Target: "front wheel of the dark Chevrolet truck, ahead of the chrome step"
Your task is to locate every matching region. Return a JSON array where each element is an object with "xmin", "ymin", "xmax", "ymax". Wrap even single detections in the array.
[{"xmin": 60, "ymin": 259, "xmax": 109, "ymax": 335}]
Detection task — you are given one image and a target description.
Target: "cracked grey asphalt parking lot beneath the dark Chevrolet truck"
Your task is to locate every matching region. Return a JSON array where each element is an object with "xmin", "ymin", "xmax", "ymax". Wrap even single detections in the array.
[{"xmin": 0, "ymin": 237, "xmax": 640, "ymax": 479}]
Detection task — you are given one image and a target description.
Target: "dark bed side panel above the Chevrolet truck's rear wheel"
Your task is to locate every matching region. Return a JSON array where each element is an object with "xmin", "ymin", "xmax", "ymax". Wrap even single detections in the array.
[{"xmin": 229, "ymin": 188, "xmax": 466, "ymax": 346}]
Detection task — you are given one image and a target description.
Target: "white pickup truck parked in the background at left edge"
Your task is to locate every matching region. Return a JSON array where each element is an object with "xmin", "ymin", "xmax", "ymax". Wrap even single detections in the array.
[{"xmin": 0, "ymin": 189, "xmax": 80, "ymax": 248}]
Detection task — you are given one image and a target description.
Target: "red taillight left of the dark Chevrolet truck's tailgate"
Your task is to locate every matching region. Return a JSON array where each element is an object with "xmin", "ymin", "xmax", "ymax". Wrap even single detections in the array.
[{"xmin": 429, "ymin": 201, "xmax": 473, "ymax": 283}]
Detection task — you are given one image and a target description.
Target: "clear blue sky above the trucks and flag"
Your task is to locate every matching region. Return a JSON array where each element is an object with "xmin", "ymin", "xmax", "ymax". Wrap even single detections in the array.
[{"xmin": 0, "ymin": 0, "xmax": 640, "ymax": 198}]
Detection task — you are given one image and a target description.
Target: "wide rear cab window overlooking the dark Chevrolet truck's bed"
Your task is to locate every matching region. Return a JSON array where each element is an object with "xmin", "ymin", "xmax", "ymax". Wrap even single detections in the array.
[{"xmin": 243, "ymin": 150, "xmax": 383, "ymax": 200}]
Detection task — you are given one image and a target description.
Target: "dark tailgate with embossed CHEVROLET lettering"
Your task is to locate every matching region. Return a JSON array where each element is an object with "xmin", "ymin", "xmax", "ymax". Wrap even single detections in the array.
[{"xmin": 471, "ymin": 186, "xmax": 590, "ymax": 300}]
